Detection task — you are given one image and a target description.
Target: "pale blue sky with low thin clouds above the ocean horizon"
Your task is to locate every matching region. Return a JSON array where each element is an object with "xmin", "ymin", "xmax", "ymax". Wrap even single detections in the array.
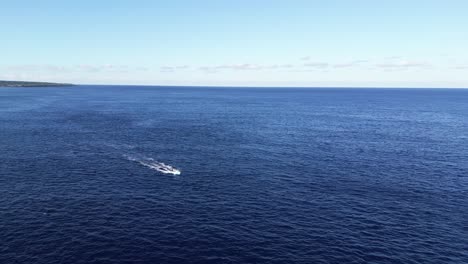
[{"xmin": 0, "ymin": 0, "xmax": 468, "ymax": 87}]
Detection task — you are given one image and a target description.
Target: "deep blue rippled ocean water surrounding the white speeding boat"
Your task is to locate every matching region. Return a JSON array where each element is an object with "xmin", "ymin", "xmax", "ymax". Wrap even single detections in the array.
[{"xmin": 0, "ymin": 86, "xmax": 468, "ymax": 264}]
